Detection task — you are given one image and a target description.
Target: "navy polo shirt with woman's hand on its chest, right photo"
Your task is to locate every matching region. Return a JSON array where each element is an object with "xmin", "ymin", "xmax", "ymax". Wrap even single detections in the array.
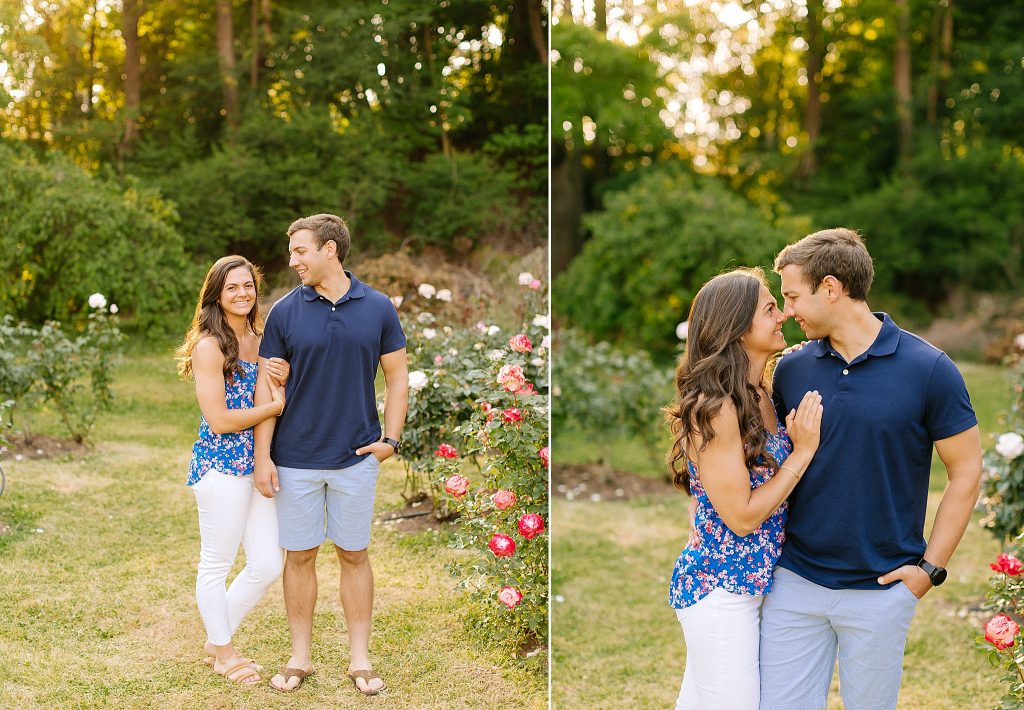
[{"xmin": 773, "ymin": 314, "xmax": 978, "ymax": 589}]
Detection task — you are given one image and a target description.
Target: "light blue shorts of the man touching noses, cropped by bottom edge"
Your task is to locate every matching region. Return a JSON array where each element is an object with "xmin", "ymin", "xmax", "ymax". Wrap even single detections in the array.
[{"xmin": 760, "ymin": 567, "xmax": 918, "ymax": 710}]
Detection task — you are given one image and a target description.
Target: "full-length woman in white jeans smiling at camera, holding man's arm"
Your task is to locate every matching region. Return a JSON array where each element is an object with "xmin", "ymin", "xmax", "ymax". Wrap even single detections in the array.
[{"xmin": 177, "ymin": 256, "xmax": 289, "ymax": 684}]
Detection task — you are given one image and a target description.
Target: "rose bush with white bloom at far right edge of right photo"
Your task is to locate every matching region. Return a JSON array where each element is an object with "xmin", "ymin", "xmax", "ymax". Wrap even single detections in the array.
[{"xmin": 981, "ymin": 352, "xmax": 1024, "ymax": 541}]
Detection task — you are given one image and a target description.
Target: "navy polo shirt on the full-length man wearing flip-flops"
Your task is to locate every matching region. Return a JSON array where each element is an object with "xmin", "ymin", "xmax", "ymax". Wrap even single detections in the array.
[{"xmin": 259, "ymin": 272, "xmax": 406, "ymax": 468}]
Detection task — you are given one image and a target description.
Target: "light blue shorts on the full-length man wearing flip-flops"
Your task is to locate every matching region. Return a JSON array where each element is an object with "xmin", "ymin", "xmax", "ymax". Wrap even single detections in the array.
[{"xmin": 276, "ymin": 454, "xmax": 381, "ymax": 552}]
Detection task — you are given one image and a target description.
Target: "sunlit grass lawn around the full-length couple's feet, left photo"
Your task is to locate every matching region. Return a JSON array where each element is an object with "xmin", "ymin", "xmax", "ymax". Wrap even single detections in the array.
[{"xmin": 0, "ymin": 354, "xmax": 547, "ymax": 710}]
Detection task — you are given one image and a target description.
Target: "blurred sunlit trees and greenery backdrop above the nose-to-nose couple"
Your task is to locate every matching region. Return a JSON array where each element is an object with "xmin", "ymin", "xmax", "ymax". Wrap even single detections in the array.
[{"xmin": 551, "ymin": 0, "xmax": 1024, "ymax": 362}]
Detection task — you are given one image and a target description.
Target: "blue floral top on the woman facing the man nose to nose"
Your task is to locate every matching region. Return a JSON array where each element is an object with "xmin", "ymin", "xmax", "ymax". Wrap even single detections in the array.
[{"xmin": 669, "ymin": 426, "xmax": 793, "ymax": 609}]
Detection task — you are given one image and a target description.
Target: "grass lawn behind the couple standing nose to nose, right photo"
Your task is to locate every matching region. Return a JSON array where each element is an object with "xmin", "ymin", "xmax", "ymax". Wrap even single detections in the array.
[{"xmin": 551, "ymin": 365, "xmax": 1010, "ymax": 710}]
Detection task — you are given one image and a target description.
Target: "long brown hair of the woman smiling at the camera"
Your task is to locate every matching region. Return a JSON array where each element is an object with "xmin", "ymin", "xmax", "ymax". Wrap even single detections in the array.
[{"xmin": 174, "ymin": 254, "xmax": 263, "ymax": 381}]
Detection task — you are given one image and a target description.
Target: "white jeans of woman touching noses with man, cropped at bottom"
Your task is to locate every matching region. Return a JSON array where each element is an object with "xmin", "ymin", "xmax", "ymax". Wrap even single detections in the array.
[{"xmin": 676, "ymin": 589, "xmax": 764, "ymax": 710}]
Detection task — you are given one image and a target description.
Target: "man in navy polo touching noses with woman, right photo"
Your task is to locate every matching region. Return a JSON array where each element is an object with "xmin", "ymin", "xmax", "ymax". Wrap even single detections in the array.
[{"xmin": 760, "ymin": 228, "xmax": 981, "ymax": 710}]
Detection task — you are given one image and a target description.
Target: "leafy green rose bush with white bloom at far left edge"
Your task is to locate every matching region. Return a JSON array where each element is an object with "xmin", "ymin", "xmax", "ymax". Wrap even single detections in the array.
[{"xmin": 0, "ymin": 307, "xmax": 124, "ymax": 444}]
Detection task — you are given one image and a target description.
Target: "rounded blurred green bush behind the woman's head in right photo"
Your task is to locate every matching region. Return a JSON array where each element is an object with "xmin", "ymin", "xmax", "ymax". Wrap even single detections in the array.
[{"xmin": 555, "ymin": 170, "xmax": 787, "ymax": 362}]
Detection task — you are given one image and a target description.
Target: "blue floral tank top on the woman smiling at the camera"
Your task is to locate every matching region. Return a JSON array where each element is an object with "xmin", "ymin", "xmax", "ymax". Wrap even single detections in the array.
[{"xmin": 186, "ymin": 360, "xmax": 257, "ymax": 486}]
